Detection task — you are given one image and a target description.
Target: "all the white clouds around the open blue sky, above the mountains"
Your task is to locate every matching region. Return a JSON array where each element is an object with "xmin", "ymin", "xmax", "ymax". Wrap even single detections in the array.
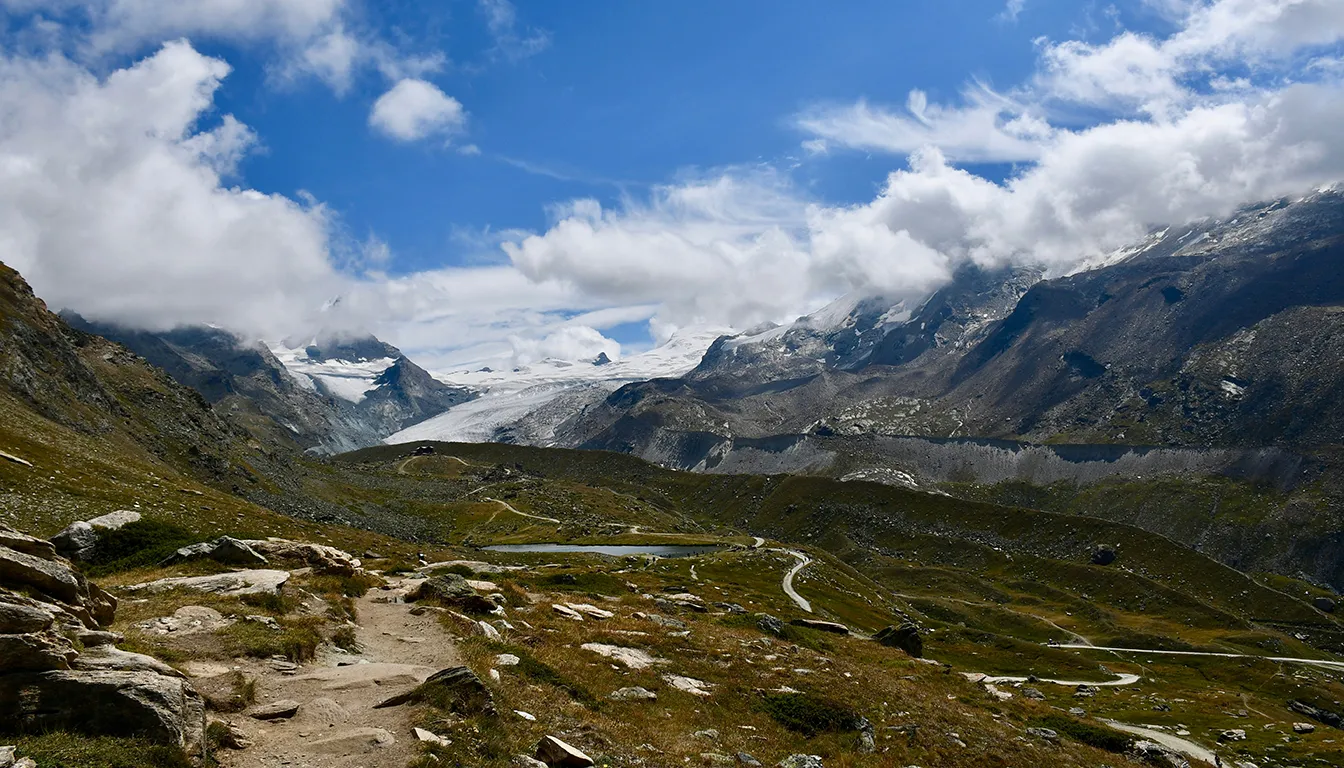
[{"xmin": 0, "ymin": 0, "xmax": 1344, "ymax": 362}]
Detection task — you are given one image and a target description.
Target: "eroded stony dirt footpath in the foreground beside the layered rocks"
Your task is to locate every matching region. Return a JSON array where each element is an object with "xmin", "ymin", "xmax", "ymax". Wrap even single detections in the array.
[{"xmin": 209, "ymin": 589, "xmax": 461, "ymax": 768}]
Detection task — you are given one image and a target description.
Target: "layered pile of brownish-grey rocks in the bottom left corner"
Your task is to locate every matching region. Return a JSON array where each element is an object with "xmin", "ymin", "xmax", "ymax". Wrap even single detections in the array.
[{"xmin": 0, "ymin": 523, "xmax": 206, "ymax": 755}]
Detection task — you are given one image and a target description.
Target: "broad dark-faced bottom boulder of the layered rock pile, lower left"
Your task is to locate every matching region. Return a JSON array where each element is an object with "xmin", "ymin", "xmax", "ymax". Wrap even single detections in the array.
[{"xmin": 0, "ymin": 670, "xmax": 206, "ymax": 752}]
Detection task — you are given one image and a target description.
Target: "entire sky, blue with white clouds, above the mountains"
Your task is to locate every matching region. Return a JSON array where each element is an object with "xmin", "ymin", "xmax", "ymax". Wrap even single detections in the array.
[{"xmin": 0, "ymin": 0, "xmax": 1344, "ymax": 367}]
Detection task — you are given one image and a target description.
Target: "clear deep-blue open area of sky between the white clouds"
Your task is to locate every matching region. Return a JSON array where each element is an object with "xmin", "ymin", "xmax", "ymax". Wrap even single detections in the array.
[{"xmin": 225, "ymin": 0, "xmax": 1098, "ymax": 272}]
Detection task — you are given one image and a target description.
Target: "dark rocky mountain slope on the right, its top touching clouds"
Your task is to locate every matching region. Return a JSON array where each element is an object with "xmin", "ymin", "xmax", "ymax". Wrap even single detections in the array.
[{"xmin": 560, "ymin": 191, "xmax": 1344, "ymax": 455}]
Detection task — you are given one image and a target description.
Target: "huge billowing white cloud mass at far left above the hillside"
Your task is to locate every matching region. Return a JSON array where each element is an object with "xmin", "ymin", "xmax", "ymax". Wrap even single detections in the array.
[{"xmin": 0, "ymin": 43, "xmax": 347, "ymax": 332}]
